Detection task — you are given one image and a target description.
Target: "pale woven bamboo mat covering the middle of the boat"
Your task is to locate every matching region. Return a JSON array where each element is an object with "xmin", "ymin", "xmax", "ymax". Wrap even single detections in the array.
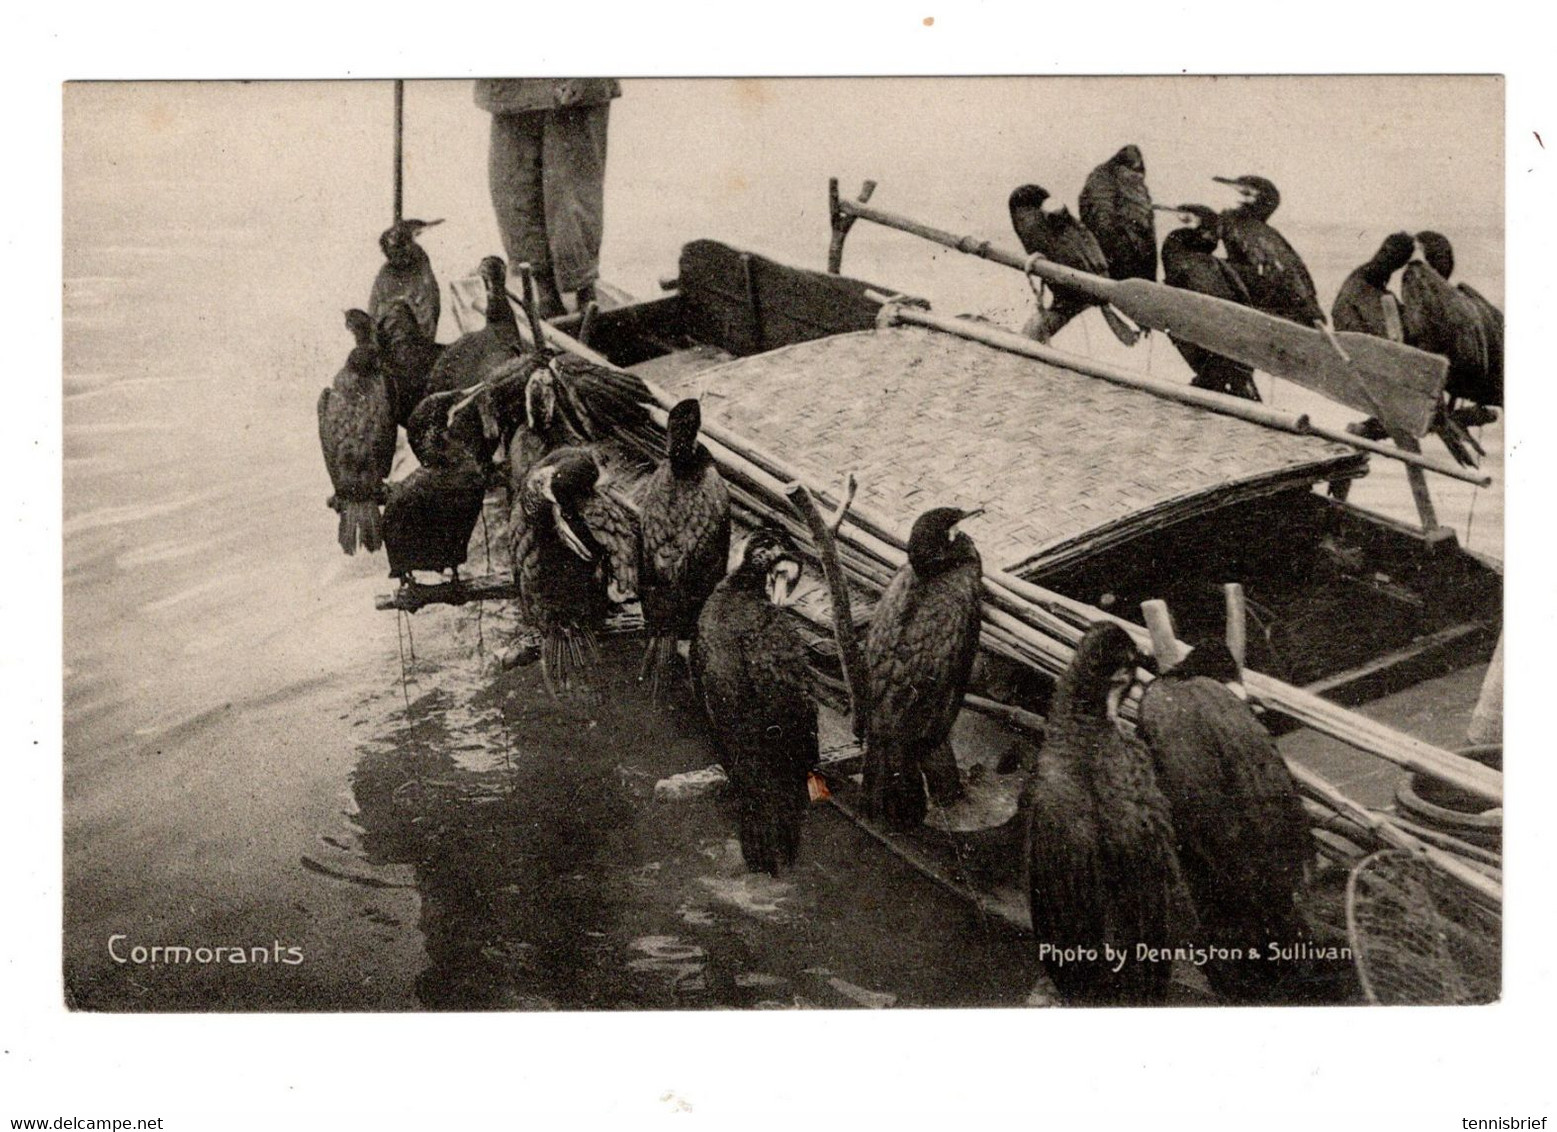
[{"xmin": 653, "ymin": 327, "xmax": 1365, "ymax": 573}]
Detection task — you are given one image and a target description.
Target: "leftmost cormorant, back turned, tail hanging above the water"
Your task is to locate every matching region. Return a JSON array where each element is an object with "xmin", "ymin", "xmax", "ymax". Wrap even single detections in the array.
[{"xmin": 318, "ymin": 310, "xmax": 395, "ymax": 554}]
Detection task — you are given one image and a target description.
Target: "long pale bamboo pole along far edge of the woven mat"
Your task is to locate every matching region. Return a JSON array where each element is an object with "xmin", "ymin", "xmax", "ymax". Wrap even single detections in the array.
[{"xmin": 866, "ymin": 291, "xmax": 1492, "ymax": 487}]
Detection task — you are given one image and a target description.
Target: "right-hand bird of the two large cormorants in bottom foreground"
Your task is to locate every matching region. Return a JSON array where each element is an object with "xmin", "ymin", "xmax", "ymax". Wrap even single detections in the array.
[{"xmin": 1140, "ymin": 642, "xmax": 1319, "ymax": 1003}]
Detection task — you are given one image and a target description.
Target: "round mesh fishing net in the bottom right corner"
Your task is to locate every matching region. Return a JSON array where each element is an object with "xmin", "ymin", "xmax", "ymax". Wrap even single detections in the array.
[{"xmin": 1347, "ymin": 849, "xmax": 1503, "ymax": 1006}]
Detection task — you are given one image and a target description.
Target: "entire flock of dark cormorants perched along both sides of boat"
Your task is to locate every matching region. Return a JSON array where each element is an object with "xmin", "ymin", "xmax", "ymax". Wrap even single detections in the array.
[{"xmin": 319, "ymin": 157, "xmax": 1503, "ymax": 1003}]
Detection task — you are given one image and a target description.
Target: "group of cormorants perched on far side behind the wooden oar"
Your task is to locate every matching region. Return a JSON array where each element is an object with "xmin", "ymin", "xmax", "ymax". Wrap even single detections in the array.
[{"xmin": 1009, "ymin": 145, "xmax": 1503, "ymax": 451}]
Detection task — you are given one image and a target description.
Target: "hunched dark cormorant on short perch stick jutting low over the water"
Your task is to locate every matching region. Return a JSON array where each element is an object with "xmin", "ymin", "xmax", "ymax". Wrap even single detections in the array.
[{"xmin": 385, "ymin": 423, "xmax": 486, "ymax": 584}]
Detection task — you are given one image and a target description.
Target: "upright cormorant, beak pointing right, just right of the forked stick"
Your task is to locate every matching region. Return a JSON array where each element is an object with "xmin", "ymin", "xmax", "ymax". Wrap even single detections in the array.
[{"xmin": 864, "ymin": 508, "xmax": 984, "ymax": 830}]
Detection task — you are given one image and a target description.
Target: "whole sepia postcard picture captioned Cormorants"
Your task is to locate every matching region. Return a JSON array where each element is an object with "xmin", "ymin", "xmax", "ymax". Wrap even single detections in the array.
[{"xmin": 62, "ymin": 75, "xmax": 1504, "ymax": 1012}]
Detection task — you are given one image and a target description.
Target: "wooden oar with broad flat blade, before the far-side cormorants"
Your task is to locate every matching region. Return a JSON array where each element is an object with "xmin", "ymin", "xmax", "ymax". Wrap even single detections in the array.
[{"xmin": 838, "ymin": 199, "xmax": 1450, "ymax": 436}]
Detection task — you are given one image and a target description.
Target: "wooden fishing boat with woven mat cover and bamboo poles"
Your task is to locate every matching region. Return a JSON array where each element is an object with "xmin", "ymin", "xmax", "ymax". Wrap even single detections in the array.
[{"xmin": 380, "ymin": 193, "xmax": 1503, "ymax": 997}]
